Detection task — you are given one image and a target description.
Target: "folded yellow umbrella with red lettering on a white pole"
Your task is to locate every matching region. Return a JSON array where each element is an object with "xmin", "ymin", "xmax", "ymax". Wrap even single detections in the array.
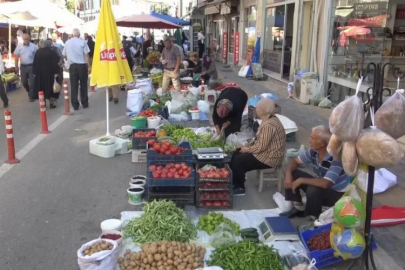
[{"xmin": 90, "ymin": 0, "xmax": 133, "ymax": 135}]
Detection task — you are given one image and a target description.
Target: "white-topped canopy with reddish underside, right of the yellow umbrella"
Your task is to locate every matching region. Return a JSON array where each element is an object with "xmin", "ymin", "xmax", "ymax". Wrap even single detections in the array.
[{"xmin": 117, "ymin": 14, "xmax": 181, "ymax": 29}]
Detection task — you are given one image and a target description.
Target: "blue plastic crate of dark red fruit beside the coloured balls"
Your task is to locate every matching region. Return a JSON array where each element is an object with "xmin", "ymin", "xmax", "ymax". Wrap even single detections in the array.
[{"xmin": 300, "ymin": 224, "xmax": 343, "ymax": 268}]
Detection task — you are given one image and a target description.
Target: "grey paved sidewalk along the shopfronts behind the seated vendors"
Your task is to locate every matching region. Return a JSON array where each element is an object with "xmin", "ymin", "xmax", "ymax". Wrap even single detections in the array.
[{"xmin": 217, "ymin": 64, "xmax": 405, "ymax": 269}]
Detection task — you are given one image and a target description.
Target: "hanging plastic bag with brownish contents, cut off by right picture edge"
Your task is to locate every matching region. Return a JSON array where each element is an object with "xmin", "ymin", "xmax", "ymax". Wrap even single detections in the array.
[{"xmin": 374, "ymin": 89, "xmax": 405, "ymax": 139}]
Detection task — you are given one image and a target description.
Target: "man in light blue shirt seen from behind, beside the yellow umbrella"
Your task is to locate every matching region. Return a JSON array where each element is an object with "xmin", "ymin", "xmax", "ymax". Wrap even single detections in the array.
[{"xmin": 63, "ymin": 28, "xmax": 91, "ymax": 111}]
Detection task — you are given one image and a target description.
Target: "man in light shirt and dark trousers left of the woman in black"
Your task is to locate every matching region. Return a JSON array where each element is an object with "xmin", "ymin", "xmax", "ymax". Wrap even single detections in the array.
[{"xmin": 14, "ymin": 34, "xmax": 38, "ymax": 102}]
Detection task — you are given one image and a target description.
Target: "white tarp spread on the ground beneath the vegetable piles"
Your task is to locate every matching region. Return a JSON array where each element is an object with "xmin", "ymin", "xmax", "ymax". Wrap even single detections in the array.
[{"xmin": 117, "ymin": 208, "xmax": 305, "ymax": 269}]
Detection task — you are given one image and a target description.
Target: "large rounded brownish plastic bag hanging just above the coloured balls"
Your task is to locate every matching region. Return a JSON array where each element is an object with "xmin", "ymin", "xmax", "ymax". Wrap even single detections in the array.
[{"xmin": 356, "ymin": 127, "xmax": 404, "ymax": 168}]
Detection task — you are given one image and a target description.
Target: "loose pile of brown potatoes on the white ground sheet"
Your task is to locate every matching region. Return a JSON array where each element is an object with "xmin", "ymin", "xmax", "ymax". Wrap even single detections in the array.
[{"xmin": 118, "ymin": 242, "xmax": 206, "ymax": 270}]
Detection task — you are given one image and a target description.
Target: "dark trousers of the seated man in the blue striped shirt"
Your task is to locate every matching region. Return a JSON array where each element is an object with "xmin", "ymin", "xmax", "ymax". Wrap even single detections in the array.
[{"xmin": 285, "ymin": 170, "xmax": 343, "ymax": 218}]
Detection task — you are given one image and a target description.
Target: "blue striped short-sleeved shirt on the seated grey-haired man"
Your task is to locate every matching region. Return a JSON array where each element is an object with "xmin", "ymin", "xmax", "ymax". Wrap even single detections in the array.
[{"xmin": 299, "ymin": 149, "xmax": 350, "ymax": 191}]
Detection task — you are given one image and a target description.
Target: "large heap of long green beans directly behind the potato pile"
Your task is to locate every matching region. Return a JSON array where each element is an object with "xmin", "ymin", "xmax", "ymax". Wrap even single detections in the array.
[{"xmin": 125, "ymin": 200, "xmax": 197, "ymax": 244}]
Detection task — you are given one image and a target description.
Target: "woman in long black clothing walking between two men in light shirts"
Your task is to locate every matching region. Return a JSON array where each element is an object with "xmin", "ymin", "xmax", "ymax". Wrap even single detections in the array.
[{"xmin": 33, "ymin": 39, "xmax": 60, "ymax": 109}]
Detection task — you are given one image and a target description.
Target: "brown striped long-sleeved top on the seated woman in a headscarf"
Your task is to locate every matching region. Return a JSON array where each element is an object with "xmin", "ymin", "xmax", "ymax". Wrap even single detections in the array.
[{"xmin": 248, "ymin": 116, "xmax": 286, "ymax": 168}]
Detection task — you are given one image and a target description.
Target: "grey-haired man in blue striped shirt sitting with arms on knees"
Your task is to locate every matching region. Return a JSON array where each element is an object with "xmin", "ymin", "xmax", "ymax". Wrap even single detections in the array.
[{"xmin": 280, "ymin": 126, "xmax": 350, "ymax": 219}]
